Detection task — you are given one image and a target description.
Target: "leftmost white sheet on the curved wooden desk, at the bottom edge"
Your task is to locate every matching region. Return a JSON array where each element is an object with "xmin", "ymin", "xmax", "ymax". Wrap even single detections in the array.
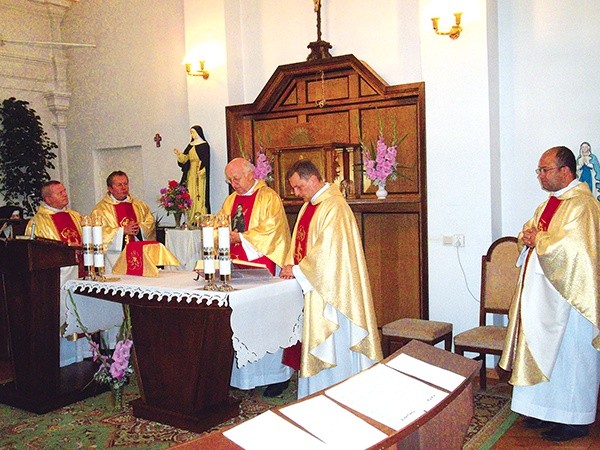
[{"xmin": 223, "ymin": 411, "xmax": 327, "ymax": 450}]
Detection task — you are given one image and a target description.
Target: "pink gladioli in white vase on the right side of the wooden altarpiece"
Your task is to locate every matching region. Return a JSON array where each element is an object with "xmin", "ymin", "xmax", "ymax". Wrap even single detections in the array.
[{"xmin": 359, "ymin": 114, "xmax": 408, "ymax": 198}]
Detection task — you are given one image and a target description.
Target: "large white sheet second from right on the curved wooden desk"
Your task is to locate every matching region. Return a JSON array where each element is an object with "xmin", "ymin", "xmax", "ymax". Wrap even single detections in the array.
[{"xmin": 325, "ymin": 364, "xmax": 448, "ymax": 430}]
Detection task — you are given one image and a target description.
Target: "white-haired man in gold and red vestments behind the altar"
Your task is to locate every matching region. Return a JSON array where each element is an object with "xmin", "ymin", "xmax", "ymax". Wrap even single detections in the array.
[{"xmin": 221, "ymin": 158, "xmax": 293, "ymax": 397}]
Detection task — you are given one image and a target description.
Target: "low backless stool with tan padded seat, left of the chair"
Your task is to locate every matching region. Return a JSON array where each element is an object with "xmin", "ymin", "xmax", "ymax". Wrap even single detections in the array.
[{"xmin": 382, "ymin": 318, "xmax": 452, "ymax": 358}]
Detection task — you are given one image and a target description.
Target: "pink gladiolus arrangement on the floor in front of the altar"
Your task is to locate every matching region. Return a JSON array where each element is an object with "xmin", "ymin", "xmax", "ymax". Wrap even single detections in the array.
[{"xmin": 69, "ymin": 292, "xmax": 133, "ymax": 409}]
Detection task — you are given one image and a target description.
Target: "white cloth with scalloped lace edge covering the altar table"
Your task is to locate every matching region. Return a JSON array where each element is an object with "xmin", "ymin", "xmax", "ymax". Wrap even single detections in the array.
[{"xmin": 64, "ymin": 270, "xmax": 304, "ymax": 367}]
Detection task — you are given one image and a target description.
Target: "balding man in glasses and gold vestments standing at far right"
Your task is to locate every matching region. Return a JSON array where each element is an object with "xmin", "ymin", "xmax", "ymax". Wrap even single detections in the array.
[{"xmin": 500, "ymin": 147, "xmax": 600, "ymax": 441}]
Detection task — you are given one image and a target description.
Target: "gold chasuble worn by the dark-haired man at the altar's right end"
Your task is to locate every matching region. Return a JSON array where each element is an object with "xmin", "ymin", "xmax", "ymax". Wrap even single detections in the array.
[{"xmin": 286, "ymin": 184, "xmax": 383, "ymax": 377}]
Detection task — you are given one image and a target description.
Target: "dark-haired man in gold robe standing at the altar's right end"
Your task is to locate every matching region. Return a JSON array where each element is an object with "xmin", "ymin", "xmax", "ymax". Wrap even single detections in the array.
[{"xmin": 280, "ymin": 160, "xmax": 383, "ymax": 398}]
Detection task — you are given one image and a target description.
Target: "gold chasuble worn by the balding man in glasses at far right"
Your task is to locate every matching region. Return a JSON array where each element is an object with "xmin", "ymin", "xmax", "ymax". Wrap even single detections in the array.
[{"xmin": 500, "ymin": 183, "xmax": 600, "ymax": 386}]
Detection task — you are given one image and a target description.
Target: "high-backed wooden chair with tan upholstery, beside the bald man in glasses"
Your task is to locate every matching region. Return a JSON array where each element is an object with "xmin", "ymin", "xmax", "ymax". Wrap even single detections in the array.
[{"xmin": 454, "ymin": 236, "xmax": 520, "ymax": 390}]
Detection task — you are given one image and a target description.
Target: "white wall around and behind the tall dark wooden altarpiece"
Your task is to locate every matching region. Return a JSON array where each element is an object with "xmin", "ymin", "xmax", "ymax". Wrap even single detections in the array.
[{"xmin": 0, "ymin": 0, "xmax": 600, "ymax": 344}]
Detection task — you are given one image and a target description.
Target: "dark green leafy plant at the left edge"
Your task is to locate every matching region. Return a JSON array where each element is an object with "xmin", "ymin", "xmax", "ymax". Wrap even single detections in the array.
[{"xmin": 0, "ymin": 97, "xmax": 58, "ymax": 215}]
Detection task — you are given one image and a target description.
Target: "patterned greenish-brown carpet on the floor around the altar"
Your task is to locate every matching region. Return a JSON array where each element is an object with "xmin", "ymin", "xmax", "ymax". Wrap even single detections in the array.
[{"xmin": 0, "ymin": 376, "xmax": 510, "ymax": 450}]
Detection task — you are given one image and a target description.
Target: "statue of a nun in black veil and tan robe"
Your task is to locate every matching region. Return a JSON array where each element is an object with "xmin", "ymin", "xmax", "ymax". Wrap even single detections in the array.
[{"xmin": 173, "ymin": 125, "xmax": 210, "ymax": 224}]
